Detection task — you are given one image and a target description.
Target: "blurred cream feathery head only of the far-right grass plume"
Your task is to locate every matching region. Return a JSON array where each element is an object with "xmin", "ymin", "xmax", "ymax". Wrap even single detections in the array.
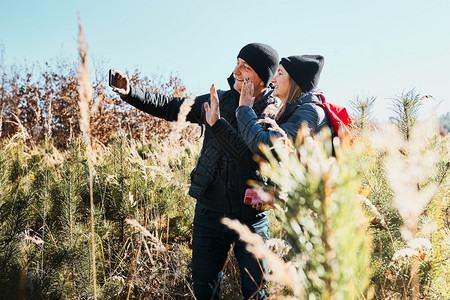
[{"xmin": 372, "ymin": 120, "xmax": 439, "ymax": 241}]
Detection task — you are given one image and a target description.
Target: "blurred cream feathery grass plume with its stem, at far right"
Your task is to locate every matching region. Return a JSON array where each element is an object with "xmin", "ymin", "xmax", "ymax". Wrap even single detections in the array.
[{"xmin": 371, "ymin": 116, "xmax": 442, "ymax": 299}]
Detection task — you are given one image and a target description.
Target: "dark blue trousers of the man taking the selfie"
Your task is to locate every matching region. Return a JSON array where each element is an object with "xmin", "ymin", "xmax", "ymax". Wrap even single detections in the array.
[{"xmin": 192, "ymin": 204, "xmax": 269, "ymax": 300}]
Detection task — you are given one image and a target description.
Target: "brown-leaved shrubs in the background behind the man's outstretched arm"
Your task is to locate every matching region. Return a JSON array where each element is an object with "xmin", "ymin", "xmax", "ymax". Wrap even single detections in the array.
[{"xmin": 0, "ymin": 52, "xmax": 199, "ymax": 149}]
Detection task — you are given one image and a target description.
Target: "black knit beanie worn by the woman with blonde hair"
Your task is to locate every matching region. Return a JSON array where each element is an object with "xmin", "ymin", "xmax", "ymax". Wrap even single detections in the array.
[{"xmin": 280, "ymin": 55, "xmax": 324, "ymax": 93}]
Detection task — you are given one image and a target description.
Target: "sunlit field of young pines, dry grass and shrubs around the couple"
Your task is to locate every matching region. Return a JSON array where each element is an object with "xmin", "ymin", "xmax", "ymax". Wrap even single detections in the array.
[{"xmin": 0, "ymin": 19, "xmax": 450, "ymax": 299}]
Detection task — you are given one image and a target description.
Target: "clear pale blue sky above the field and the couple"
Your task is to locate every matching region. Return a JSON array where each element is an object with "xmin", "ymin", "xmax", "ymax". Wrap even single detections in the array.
[{"xmin": 0, "ymin": 0, "xmax": 450, "ymax": 120}]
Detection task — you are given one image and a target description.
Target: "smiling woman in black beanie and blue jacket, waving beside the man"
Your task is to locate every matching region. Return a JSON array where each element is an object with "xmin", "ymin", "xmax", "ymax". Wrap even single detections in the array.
[{"xmin": 236, "ymin": 55, "xmax": 329, "ymax": 155}]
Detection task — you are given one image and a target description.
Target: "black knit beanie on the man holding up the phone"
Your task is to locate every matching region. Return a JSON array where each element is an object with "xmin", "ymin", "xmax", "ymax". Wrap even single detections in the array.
[{"xmin": 238, "ymin": 43, "xmax": 279, "ymax": 86}]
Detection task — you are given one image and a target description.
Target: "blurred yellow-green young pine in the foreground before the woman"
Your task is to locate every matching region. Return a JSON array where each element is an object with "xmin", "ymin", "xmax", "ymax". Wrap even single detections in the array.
[{"xmin": 256, "ymin": 125, "xmax": 371, "ymax": 299}]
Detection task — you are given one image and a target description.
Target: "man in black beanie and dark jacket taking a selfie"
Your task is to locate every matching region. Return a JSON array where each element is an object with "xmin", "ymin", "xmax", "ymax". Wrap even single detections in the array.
[{"xmin": 113, "ymin": 43, "xmax": 279, "ymax": 300}]
